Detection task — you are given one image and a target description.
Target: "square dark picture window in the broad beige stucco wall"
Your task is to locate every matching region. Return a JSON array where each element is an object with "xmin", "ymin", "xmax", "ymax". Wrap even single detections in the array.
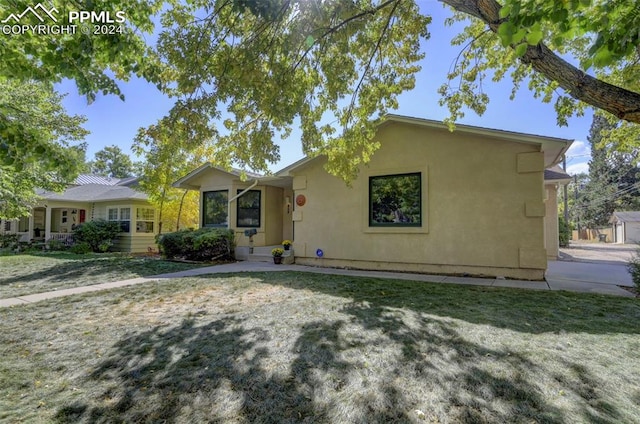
[{"xmin": 369, "ymin": 172, "xmax": 422, "ymax": 227}]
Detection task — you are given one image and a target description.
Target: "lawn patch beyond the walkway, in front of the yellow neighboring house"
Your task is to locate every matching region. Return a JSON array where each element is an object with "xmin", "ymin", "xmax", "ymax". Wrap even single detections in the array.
[{"xmin": 0, "ymin": 252, "xmax": 210, "ymax": 299}]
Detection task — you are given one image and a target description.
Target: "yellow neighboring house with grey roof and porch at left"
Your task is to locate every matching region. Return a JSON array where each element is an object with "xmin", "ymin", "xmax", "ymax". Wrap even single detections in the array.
[{"xmin": 0, "ymin": 175, "xmax": 158, "ymax": 252}]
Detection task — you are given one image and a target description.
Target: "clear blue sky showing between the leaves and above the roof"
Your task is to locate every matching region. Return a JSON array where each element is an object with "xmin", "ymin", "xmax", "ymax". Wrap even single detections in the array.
[{"xmin": 58, "ymin": 0, "xmax": 591, "ymax": 174}]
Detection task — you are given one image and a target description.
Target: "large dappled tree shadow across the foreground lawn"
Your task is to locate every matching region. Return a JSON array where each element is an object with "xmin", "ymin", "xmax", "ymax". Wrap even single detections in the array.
[{"xmin": 56, "ymin": 314, "xmax": 563, "ymax": 423}]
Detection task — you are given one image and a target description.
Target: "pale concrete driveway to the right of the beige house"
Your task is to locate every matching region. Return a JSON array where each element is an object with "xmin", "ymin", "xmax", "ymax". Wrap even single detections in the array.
[{"xmin": 545, "ymin": 243, "xmax": 637, "ymax": 297}]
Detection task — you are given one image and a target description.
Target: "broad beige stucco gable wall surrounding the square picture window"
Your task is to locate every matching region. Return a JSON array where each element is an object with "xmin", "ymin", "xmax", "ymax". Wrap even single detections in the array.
[{"xmin": 293, "ymin": 123, "xmax": 546, "ymax": 279}]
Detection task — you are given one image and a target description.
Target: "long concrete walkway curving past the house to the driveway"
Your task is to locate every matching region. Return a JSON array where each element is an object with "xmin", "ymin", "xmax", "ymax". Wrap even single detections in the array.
[{"xmin": 0, "ymin": 261, "xmax": 633, "ymax": 307}]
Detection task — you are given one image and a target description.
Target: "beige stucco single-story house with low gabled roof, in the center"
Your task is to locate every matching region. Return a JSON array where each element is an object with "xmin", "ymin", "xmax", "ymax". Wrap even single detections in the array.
[{"xmin": 174, "ymin": 115, "xmax": 571, "ymax": 280}]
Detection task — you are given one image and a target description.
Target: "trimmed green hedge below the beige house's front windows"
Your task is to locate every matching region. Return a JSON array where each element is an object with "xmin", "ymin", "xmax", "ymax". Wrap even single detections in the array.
[{"xmin": 158, "ymin": 228, "xmax": 234, "ymax": 261}]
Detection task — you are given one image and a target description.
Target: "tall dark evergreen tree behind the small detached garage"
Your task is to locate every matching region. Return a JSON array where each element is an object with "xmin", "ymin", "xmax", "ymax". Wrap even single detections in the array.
[{"xmin": 574, "ymin": 115, "xmax": 640, "ymax": 227}]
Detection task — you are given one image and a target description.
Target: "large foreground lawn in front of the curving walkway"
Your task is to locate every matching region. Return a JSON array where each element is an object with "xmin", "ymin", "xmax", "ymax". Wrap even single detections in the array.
[{"xmin": 0, "ymin": 272, "xmax": 640, "ymax": 423}]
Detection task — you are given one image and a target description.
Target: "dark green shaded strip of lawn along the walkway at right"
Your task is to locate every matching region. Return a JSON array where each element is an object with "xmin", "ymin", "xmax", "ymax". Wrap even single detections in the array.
[{"xmin": 262, "ymin": 272, "xmax": 640, "ymax": 334}]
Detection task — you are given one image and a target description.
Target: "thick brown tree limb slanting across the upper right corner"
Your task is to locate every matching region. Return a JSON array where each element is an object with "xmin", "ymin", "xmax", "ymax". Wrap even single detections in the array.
[{"xmin": 440, "ymin": 0, "xmax": 640, "ymax": 124}]
